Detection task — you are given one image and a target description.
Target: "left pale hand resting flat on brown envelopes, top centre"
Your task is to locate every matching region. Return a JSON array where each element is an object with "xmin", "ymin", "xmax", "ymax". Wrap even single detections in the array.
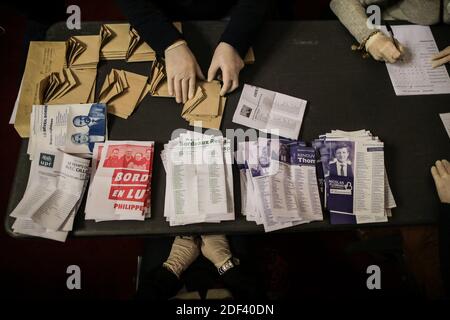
[{"xmin": 164, "ymin": 41, "xmax": 205, "ymax": 103}]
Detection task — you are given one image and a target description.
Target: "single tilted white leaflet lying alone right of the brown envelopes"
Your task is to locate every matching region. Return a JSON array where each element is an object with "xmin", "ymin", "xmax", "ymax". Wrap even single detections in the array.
[{"xmin": 233, "ymin": 84, "xmax": 306, "ymax": 140}]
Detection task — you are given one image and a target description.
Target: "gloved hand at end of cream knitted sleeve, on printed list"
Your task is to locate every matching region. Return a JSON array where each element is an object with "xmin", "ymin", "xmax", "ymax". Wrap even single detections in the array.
[{"xmin": 366, "ymin": 32, "xmax": 405, "ymax": 63}]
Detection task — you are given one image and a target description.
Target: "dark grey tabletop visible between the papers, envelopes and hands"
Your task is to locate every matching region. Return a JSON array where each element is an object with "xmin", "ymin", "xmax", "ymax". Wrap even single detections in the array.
[{"xmin": 5, "ymin": 21, "xmax": 450, "ymax": 237}]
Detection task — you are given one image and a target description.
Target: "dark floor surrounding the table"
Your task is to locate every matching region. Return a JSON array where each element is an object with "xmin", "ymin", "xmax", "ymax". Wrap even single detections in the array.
[{"xmin": 0, "ymin": 0, "xmax": 440, "ymax": 299}]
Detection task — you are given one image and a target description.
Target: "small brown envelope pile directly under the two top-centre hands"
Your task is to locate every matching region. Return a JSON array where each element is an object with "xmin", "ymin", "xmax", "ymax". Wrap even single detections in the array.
[{"xmin": 181, "ymin": 80, "xmax": 227, "ymax": 129}]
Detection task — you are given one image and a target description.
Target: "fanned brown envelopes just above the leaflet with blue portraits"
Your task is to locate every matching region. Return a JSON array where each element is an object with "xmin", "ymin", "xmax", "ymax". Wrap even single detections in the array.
[{"xmin": 99, "ymin": 69, "xmax": 148, "ymax": 119}]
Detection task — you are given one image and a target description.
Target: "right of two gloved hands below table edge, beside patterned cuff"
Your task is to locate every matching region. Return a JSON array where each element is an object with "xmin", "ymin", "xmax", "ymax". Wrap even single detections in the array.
[{"xmin": 201, "ymin": 235, "xmax": 232, "ymax": 268}]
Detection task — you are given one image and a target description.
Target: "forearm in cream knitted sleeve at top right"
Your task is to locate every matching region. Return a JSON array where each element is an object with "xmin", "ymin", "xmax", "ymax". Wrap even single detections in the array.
[{"xmin": 330, "ymin": 0, "xmax": 374, "ymax": 43}]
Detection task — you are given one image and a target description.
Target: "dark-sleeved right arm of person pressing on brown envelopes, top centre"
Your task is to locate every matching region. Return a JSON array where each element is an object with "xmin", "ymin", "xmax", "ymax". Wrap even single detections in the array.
[{"xmin": 220, "ymin": 0, "xmax": 269, "ymax": 58}]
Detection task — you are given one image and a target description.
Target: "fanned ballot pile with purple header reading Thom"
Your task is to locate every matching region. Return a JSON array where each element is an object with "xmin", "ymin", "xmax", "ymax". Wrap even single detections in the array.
[{"xmin": 235, "ymin": 137, "xmax": 323, "ymax": 232}]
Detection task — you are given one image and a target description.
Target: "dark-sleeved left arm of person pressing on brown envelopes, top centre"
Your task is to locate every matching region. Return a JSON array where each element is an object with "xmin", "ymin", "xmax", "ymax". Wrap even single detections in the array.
[{"xmin": 116, "ymin": 0, "xmax": 182, "ymax": 56}]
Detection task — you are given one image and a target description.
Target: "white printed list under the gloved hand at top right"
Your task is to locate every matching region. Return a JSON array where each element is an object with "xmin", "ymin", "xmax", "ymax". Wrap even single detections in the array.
[{"xmin": 382, "ymin": 25, "xmax": 450, "ymax": 96}]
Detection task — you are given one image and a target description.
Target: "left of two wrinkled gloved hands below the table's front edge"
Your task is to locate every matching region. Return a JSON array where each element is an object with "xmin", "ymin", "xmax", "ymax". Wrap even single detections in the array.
[{"xmin": 163, "ymin": 237, "xmax": 200, "ymax": 278}]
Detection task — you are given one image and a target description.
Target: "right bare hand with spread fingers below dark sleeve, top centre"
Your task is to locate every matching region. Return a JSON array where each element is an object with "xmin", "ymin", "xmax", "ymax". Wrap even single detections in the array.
[{"xmin": 208, "ymin": 42, "xmax": 244, "ymax": 96}]
